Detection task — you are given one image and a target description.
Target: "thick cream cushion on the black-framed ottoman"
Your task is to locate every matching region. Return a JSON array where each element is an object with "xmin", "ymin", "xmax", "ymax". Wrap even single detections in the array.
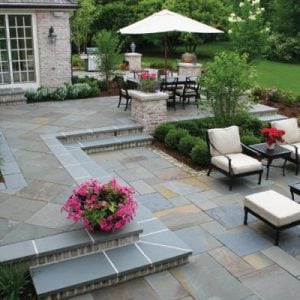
[{"xmin": 244, "ymin": 190, "xmax": 300, "ymax": 227}]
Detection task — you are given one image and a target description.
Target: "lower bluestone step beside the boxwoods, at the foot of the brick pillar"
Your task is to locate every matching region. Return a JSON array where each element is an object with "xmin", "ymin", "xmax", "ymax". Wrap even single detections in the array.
[{"xmin": 80, "ymin": 133, "xmax": 153, "ymax": 154}]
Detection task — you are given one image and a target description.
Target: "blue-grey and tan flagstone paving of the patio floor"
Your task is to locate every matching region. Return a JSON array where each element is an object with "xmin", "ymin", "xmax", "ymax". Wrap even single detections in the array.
[{"xmin": 0, "ymin": 96, "xmax": 300, "ymax": 300}]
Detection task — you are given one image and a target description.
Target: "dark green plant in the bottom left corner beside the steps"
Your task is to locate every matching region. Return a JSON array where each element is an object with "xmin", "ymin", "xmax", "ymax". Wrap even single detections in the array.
[{"xmin": 0, "ymin": 263, "xmax": 29, "ymax": 300}]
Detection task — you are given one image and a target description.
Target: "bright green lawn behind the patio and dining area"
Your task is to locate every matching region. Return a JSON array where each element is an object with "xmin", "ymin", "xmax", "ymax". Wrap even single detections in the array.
[{"xmin": 142, "ymin": 42, "xmax": 300, "ymax": 95}]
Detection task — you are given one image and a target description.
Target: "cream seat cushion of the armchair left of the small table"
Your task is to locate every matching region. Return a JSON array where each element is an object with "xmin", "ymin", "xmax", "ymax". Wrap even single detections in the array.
[{"xmin": 211, "ymin": 153, "xmax": 262, "ymax": 175}]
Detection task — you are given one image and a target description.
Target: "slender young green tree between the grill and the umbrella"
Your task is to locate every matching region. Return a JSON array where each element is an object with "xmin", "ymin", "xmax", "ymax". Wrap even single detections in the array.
[{"xmin": 95, "ymin": 29, "xmax": 120, "ymax": 87}]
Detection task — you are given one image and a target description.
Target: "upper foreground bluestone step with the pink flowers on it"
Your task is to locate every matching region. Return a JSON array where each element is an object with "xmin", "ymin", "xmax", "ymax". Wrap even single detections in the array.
[{"xmin": 0, "ymin": 222, "xmax": 143, "ymax": 266}]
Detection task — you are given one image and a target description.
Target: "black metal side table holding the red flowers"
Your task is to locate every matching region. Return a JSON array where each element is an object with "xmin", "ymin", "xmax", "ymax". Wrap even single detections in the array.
[{"xmin": 249, "ymin": 143, "xmax": 291, "ymax": 179}]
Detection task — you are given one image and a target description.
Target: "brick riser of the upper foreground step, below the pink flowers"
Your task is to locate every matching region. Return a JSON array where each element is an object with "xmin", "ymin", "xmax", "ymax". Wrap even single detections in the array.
[{"xmin": 29, "ymin": 234, "xmax": 139, "ymax": 267}]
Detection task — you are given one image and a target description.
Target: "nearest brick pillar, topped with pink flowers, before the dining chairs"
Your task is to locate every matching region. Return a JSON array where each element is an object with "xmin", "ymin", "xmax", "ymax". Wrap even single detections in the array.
[{"xmin": 128, "ymin": 90, "xmax": 169, "ymax": 133}]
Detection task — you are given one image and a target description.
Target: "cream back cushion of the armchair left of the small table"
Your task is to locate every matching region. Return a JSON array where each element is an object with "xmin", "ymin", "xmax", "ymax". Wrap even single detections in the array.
[{"xmin": 207, "ymin": 126, "xmax": 242, "ymax": 156}]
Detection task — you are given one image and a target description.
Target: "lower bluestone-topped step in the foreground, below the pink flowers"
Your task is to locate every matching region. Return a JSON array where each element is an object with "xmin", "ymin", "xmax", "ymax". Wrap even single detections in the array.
[{"xmin": 30, "ymin": 230, "xmax": 191, "ymax": 300}]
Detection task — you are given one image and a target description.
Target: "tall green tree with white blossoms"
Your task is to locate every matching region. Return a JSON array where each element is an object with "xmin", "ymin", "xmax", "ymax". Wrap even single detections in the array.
[{"xmin": 228, "ymin": 0, "xmax": 270, "ymax": 60}]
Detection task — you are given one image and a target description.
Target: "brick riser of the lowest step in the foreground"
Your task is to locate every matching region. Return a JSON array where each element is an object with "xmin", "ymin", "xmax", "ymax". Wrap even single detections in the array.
[{"xmin": 38, "ymin": 254, "xmax": 189, "ymax": 300}]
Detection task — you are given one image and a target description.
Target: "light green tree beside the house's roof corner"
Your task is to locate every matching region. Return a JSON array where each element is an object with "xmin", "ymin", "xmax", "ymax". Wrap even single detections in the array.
[{"xmin": 71, "ymin": 0, "xmax": 96, "ymax": 53}]
